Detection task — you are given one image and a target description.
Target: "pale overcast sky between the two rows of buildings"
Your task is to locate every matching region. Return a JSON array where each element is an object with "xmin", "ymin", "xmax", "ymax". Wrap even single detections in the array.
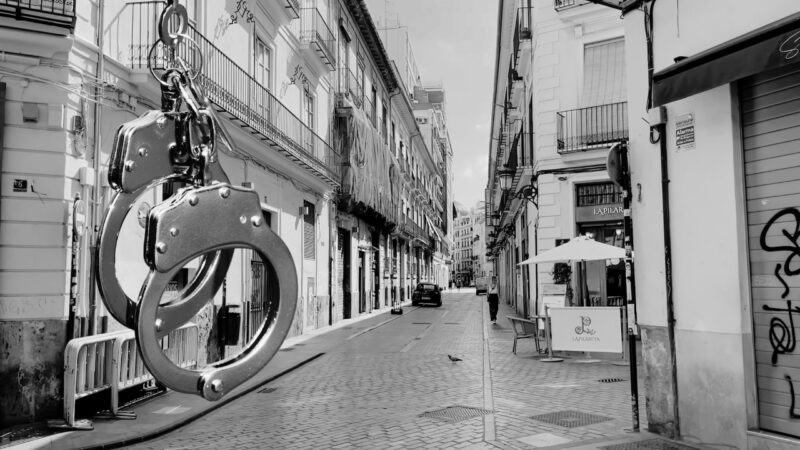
[{"xmin": 366, "ymin": 0, "xmax": 497, "ymax": 208}]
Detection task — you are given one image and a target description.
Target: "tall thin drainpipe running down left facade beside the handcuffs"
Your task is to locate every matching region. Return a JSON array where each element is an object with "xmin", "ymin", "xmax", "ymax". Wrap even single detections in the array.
[{"xmin": 87, "ymin": 2, "xmax": 105, "ymax": 335}]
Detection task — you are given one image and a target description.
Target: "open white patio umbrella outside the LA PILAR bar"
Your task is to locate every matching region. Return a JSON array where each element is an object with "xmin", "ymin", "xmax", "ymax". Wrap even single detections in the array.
[{"xmin": 518, "ymin": 236, "xmax": 625, "ymax": 305}]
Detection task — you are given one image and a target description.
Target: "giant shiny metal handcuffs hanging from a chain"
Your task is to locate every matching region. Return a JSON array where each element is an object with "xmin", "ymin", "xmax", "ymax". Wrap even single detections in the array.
[{"xmin": 95, "ymin": 0, "xmax": 297, "ymax": 400}]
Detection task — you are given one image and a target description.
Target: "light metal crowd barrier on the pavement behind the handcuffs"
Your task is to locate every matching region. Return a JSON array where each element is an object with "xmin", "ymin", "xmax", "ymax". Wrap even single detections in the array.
[{"xmin": 56, "ymin": 323, "xmax": 198, "ymax": 429}]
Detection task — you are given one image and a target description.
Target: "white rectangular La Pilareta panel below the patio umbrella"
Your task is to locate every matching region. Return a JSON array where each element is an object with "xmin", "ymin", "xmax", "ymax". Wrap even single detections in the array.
[{"xmin": 550, "ymin": 307, "xmax": 622, "ymax": 353}]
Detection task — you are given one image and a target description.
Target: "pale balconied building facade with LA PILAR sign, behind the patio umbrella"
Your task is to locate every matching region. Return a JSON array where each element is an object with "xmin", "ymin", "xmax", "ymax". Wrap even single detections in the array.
[{"xmin": 485, "ymin": 0, "xmax": 628, "ymax": 316}]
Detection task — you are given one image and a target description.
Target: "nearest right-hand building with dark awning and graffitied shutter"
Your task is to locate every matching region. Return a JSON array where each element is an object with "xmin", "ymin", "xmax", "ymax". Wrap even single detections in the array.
[{"xmin": 614, "ymin": 1, "xmax": 800, "ymax": 449}]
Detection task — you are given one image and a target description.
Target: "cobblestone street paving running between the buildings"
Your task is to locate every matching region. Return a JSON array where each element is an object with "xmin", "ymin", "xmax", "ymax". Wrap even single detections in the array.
[{"xmin": 128, "ymin": 290, "xmax": 646, "ymax": 450}]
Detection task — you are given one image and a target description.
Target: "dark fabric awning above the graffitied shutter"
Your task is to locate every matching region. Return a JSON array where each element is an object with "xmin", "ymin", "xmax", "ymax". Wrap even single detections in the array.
[{"xmin": 653, "ymin": 13, "xmax": 800, "ymax": 106}]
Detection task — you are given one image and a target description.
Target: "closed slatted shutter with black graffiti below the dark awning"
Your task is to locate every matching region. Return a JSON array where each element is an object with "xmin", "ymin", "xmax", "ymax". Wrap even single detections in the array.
[{"xmin": 740, "ymin": 62, "xmax": 800, "ymax": 437}]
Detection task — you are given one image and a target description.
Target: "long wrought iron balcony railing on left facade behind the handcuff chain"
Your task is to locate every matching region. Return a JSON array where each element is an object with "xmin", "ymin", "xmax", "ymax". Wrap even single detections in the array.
[{"xmin": 124, "ymin": 2, "xmax": 341, "ymax": 186}]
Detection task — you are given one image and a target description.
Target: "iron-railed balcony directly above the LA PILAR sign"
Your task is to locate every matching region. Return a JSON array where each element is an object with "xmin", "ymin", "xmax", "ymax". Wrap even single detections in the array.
[{"xmin": 556, "ymin": 102, "xmax": 628, "ymax": 154}]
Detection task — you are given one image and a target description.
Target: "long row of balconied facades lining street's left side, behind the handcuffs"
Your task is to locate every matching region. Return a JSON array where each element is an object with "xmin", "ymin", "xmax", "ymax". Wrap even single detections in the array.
[{"xmin": 0, "ymin": 0, "xmax": 449, "ymax": 425}]
